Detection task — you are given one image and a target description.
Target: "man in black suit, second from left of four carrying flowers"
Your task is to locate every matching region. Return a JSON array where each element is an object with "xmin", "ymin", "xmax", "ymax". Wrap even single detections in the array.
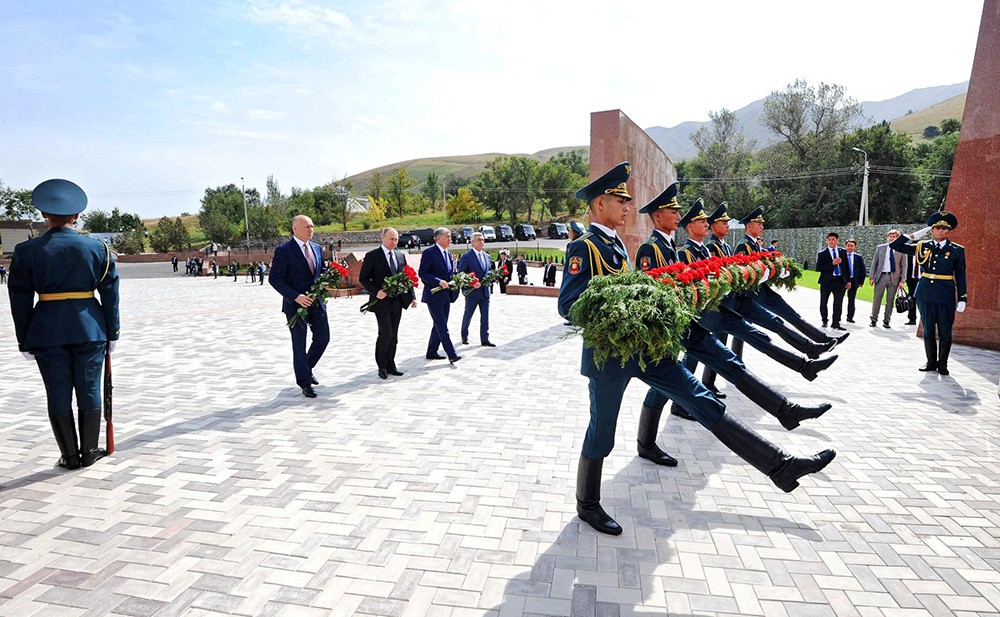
[{"xmin": 358, "ymin": 227, "xmax": 417, "ymax": 379}]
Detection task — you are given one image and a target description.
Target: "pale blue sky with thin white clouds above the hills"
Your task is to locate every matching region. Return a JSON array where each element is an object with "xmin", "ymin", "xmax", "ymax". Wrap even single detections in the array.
[{"xmin": 0, "ymin": 0, "xmax": 983, "ymax": 217}]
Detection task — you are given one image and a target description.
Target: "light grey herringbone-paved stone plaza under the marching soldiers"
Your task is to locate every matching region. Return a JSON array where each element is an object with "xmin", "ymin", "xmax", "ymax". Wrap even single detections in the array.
[{"xmin": 0, "ymin": 265, "xmax": 1000, "ymax": 617}]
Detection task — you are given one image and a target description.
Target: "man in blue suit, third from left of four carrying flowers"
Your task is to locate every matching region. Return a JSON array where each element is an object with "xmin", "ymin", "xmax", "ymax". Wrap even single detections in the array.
[{"xmin": 417, "ymin": 227, "xmax": 462, "ymax": 364}]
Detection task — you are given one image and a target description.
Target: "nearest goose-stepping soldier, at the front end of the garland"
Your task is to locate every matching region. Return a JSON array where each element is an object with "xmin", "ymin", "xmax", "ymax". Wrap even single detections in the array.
[{"xmin": 558, "ymin": 163, "xmax": 836, "ymax": 535}]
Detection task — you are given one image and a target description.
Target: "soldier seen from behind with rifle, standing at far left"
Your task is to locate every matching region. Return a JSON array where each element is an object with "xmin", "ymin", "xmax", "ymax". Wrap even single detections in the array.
[{"xmin": 9, "ymin": 180, "xmax": 118, "ymax": 469}]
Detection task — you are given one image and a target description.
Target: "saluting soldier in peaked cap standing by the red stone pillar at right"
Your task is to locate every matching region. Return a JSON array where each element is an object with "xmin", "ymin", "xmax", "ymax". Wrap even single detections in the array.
[{"xmin": 889, "ymin": 210, "xmax": 969, "ymax": 375}]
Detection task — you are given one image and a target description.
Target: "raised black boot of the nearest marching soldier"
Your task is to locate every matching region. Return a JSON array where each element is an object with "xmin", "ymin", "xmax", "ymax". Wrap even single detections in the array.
[{"xmin": 712, "ymin": 413, "xmax": 837, "ymax": 493}]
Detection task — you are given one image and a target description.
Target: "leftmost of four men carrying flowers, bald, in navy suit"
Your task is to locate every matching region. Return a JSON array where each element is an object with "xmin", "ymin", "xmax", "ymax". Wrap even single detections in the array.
[{"xmin": 268, "ymin": 214, "xmax": 330, "ymax": 398}]
